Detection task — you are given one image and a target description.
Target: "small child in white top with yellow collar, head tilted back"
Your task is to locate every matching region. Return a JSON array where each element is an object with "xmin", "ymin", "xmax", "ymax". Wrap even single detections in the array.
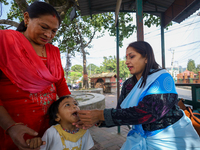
[{"xmin": 26, "ymin": 96, "xmax": 94, "ymax": 150}]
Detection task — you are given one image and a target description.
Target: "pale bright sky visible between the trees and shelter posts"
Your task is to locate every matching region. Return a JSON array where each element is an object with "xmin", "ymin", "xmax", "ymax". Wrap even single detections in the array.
[{"xmin": 0, "ymin": 1, "xmax": 200, "ymax": 68}]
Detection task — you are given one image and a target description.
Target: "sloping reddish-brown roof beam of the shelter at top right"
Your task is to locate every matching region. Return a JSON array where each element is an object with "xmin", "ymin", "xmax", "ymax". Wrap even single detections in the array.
[{"xmin": 164, "ymin": 0, "xmax": 196, "ymax": 27}]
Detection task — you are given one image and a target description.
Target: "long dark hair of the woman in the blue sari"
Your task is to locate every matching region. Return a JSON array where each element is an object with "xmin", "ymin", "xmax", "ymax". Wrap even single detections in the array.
[{"xmin": 127, "ymin": 41, "xmax": 161, "ymax": 88}]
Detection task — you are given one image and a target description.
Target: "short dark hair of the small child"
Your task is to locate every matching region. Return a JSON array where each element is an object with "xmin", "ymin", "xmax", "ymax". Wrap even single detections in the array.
[{"xmin": 47, "ymin": 96, "xmax": 71, "ymax": 126}]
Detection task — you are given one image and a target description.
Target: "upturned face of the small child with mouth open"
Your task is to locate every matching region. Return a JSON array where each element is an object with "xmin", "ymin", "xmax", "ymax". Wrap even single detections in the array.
[{"xmin": 56, "ymin": 97, "xmax": 80, "ymax": 124}]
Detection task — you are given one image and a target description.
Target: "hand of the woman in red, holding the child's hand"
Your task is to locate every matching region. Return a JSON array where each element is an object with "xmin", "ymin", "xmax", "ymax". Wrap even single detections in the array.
[{"xmin": 7, "ymin": 125, "xmax": 40, "ymax": 150}]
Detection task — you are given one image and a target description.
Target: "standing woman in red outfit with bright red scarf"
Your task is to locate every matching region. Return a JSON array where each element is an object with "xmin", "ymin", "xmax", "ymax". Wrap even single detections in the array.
[{"xmin": 0, "ymin": 1, "xmax": 71, "ymax": 150}]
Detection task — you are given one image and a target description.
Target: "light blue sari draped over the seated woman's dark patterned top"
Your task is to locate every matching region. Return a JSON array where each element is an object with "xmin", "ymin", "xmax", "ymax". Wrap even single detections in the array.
[{"xmin": 121, "ymin": 70, "xmax": 200, "ymax": 150}]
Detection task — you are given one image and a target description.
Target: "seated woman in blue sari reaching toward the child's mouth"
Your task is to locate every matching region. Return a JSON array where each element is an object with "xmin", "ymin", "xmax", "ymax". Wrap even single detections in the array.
[{"xmin": 74, "ymin": 41, "xmax": 200, "ymax": 150}]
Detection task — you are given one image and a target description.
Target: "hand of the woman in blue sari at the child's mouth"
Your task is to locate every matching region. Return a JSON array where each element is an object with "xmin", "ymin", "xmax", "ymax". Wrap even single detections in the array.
[{"xmin": 78, "ymin": 110, "xmax": 104, "ymax": 127}]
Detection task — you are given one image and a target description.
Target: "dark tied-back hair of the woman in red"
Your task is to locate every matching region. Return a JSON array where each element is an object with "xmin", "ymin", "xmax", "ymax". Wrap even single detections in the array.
[{"xmin": 16, "ymin": 1, "xmax": 61, "ymax": 32}]
